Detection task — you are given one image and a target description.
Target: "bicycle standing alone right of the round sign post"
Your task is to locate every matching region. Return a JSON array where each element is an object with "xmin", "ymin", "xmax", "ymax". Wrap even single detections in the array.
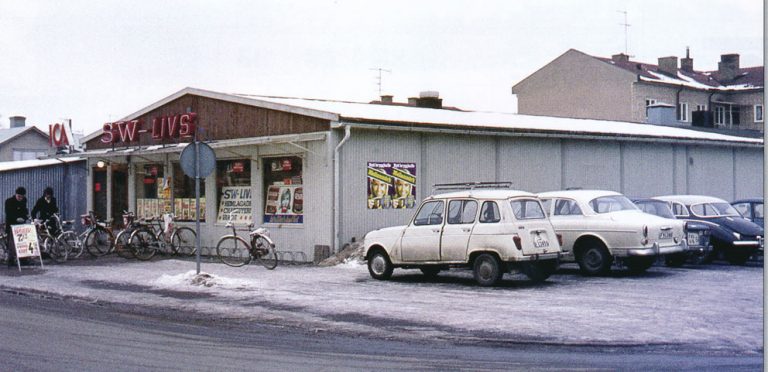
[{"xmin": 216, "ymin": 213, "xmax": 277, "ymax": 270}]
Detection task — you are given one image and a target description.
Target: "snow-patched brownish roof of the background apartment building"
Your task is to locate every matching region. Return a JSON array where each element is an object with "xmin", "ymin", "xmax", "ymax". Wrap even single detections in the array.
[{"xmin": 593, "ymin": 56, "xmax": 764, "ymax": 91}]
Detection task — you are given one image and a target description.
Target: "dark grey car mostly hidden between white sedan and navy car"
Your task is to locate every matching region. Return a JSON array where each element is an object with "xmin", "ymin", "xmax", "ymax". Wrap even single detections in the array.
[{"xmin": 632, "ymin": 198, "xmax": 712, "ymax": 267}]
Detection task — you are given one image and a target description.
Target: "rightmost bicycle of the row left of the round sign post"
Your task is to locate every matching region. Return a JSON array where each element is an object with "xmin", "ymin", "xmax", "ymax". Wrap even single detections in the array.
[{"xmin": 129, "ymin": 214, "xmax": 197, "ymax": 261}]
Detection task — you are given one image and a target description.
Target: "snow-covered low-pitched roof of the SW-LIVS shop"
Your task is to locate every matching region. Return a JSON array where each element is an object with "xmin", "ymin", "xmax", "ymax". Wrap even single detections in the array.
[{"xmin": 85, "ymin": 88, "xmax": 763, "ymax": 146}]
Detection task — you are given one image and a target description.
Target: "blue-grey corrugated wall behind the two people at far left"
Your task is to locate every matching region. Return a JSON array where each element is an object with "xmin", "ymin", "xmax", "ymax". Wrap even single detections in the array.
[{"xmin": 0, "ymin": 160, "xmax": 87, "ymax": 228}]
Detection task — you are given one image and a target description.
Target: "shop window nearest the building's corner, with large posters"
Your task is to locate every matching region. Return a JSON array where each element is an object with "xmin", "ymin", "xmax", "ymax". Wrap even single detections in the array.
[{"xmin": 262, "ymin": 156, "xmax": 304, "ymax": 224}]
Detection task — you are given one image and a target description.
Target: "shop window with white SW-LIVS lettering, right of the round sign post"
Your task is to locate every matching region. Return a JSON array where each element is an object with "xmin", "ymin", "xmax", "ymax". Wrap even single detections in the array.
[{"xmin": 216, "ymin": 159, "xmax": 253, "ymax": 225}]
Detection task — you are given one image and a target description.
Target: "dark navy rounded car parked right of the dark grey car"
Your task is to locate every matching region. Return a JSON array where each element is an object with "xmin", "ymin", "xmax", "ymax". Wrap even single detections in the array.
[{"xmin": 654, "ymin": 195, "xmax": 765, "ymax": 265}]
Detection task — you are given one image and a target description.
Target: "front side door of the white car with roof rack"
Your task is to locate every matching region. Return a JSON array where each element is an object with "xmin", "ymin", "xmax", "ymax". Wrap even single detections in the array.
[{"xmin": 401, "ymin": 200, "xmax": 445, "ymax": 262}]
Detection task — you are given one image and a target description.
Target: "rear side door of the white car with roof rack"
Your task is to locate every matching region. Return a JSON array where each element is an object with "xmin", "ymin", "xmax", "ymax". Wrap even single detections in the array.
[{"xmin": 440, "ymin": 199, "xmax": 477, "ymax": 262}]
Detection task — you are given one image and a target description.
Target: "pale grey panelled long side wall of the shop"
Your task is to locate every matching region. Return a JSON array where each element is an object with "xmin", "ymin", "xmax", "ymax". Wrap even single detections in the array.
[{"xmin": 337, "ymin": 128, "xmax": 763, "ymax": 247}]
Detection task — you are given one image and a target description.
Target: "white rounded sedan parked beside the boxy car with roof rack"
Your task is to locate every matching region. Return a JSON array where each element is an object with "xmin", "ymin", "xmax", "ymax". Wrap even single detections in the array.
[{"xmin": 539, "ymin": 190, "xmax": 687, "ymax": 275}]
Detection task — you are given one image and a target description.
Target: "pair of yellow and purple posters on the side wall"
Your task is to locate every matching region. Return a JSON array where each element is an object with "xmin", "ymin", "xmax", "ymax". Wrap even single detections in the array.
[{"xmin": 367, "ymin": 162, "xmax": 416, "ymax": 209}]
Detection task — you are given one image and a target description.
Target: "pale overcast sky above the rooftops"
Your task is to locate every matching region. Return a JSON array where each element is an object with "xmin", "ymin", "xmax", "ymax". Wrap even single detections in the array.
[{"xmin": 0, "ymin": 0, "xmax": 764, "ymax": 135}]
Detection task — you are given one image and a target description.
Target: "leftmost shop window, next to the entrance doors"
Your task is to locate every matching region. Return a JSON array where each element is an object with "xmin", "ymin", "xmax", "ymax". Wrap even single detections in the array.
[{"xmin": 136, "ymin": 164, "xmax": 171, "ymax": 218}]
